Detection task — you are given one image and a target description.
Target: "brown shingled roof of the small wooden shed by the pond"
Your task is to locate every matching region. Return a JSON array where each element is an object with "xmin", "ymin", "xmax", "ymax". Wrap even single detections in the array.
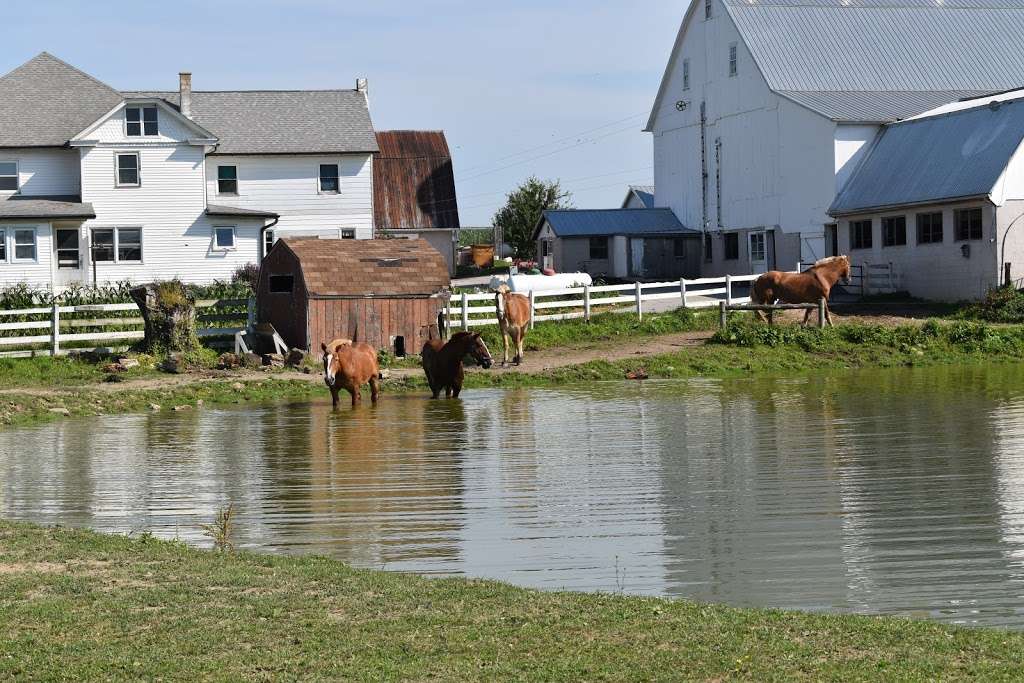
[{"xmin": 273, "ymin": 238, "xmax": 452, "ymax": 298}]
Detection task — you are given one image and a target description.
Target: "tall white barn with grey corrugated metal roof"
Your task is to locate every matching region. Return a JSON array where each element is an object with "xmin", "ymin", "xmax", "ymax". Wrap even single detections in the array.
[{"xmin": 646, "ymin": 0, "xmax": 1024, "ymax": 275}]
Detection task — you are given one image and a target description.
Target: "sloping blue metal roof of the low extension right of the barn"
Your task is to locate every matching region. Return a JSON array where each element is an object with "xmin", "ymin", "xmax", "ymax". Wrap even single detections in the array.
[{"xmin": 828, "ymin": 99, "xmax": 1024, "ymax": 215}]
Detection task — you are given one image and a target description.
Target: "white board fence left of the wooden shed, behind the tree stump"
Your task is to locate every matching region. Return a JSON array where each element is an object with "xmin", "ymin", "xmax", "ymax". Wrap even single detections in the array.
[{"xmin": 0, "ymin": 299, "xmax": 253, "ymax": 356}]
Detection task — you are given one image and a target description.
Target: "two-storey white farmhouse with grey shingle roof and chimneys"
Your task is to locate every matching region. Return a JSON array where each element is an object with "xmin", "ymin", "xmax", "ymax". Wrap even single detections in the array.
[{"xmin": 0, "ymin": 52, "xmax": 378, "ymax": 289}]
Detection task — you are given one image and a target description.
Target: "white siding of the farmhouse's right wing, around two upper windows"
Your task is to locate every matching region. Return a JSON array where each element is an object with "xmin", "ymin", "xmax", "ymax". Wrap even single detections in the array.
[{"xmin": 206, "ymin": 155, "xmax": 373, "ymax": 239}]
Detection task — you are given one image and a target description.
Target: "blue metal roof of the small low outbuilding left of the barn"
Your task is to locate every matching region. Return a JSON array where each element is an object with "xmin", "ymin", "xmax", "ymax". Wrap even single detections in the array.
[{"xmin": 538, "ymin": 209, "xmax": 699, "ymax": 238}]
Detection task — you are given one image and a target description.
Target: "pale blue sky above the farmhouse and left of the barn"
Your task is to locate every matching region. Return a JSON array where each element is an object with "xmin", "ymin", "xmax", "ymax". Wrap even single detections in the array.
[{"xmin": 0, "ymin": 0, "xmax": 687, "ymax": 226}]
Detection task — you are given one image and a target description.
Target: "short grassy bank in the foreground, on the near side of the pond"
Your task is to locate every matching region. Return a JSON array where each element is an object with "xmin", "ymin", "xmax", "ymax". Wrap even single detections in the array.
[{"xmin": 0, "ymin": 522, "xmax": 1024, "ymax": 681}]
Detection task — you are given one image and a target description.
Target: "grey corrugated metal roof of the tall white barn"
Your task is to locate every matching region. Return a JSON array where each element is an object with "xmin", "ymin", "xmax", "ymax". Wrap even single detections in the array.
[{"xmin": 647, "ymin": 0, "xmax": 1024, "ymax": 130}]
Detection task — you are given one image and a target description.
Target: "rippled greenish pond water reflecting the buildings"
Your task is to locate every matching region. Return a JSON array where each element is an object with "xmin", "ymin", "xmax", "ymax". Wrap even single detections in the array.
[{"xmin": 6, "ymin": 367, "xmax": 1024, "ymax": 628}]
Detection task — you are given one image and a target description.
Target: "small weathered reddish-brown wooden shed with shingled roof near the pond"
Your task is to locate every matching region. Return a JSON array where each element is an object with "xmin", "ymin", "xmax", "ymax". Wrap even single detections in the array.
[{"xmin": 256, "ymin": 238, "xmax": 451, "ymax": 355}]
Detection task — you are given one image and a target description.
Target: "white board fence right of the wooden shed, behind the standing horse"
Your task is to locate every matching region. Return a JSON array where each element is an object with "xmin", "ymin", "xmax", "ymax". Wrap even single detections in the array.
[{"xmin": 444, "ymin": 274, "xmax": 761, "ymax": 330}]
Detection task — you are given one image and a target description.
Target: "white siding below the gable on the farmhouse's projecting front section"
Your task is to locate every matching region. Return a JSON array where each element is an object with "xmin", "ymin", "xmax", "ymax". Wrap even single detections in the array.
[{"xmin": 82, "ymin": 144, "xmax": 262, "ymax": 282}]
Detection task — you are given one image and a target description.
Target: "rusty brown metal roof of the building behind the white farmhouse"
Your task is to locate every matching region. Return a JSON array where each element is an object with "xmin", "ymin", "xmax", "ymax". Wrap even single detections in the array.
[{"xmin": 374, "ymin": 130, "xmax": 459, "ymax": 230}]
